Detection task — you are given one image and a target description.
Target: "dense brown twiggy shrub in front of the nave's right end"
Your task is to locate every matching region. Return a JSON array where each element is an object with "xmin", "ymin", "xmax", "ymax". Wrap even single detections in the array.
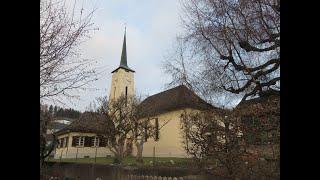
[{"xmin": 181, "ymin": 110, "xmax": 243, "ymax": 177}]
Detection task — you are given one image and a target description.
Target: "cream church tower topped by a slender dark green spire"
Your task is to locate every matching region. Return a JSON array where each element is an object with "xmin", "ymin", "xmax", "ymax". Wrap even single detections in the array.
[{"xmin": 109, "ymin": 30, "xmax": 135, "ymax": 101}]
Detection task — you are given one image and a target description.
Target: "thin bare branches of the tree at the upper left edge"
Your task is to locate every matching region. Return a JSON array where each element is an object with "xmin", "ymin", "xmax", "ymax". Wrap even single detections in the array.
[{"xmin": 40, "ymin": 0, "xmax": 96, "ymax": 101}]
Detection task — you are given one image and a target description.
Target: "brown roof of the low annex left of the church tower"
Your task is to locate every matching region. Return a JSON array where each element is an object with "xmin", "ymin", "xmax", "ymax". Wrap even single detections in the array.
[{"xmin": 55, "ymin": 112, "xmax": 113, "ymax": 135}]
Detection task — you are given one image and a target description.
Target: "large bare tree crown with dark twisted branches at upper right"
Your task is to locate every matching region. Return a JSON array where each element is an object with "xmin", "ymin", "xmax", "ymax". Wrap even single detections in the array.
[{"xmin": 165, "ymin": 0, "xmax": 280, "ymax": 99}]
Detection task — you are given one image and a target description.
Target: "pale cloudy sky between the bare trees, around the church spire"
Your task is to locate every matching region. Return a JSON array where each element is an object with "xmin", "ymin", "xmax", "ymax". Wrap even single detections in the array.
[{"xmin": 62, "ymin": 0, "xmax": 181, "ymax": 111}]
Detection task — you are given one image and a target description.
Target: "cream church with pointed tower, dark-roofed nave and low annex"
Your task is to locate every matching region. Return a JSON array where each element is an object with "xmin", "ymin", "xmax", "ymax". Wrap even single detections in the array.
[{"xmin": 54, "ymin": 30, "xmax": 216, "ymax": 159}]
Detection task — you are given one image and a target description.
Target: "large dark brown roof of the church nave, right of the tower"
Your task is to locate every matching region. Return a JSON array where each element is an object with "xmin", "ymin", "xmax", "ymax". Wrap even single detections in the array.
[{"xmin": 139, "ymin": 85, "xmax": 215, "ymax": 118}]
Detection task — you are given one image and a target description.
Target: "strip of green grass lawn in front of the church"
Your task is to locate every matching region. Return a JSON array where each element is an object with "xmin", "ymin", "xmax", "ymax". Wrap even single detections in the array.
[{"xmin": 48, "ymin": 157, "xmax": 192, "ymax": 166}]
